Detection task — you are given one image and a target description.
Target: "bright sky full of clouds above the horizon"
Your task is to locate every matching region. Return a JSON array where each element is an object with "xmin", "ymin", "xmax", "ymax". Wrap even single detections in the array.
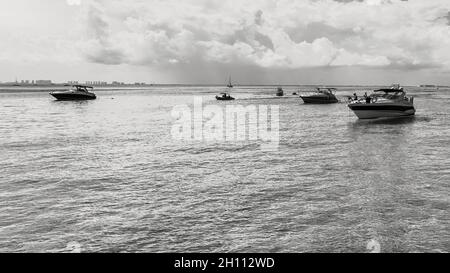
[{"xmin": 0, "ymin": 0, "xmax": 450, "ymax": 85}]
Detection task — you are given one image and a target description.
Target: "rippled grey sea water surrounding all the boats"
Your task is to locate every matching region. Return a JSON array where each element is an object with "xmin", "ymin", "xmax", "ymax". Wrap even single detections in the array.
[{"xmin": 0, "ymin": 87, "xmax": 450, "ymax": 252}]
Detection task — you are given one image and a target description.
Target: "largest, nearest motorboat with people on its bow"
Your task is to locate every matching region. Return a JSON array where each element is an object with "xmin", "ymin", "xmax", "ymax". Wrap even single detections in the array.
[{"xmin": 348, "ymin": 85, "xmax": 416, "ymax": 119}]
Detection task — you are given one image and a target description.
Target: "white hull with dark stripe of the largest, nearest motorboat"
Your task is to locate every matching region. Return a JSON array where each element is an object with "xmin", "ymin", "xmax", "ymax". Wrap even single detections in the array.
[{"xmin": 349, "ymin": 104, "xmax": 416, "ymax": 119}]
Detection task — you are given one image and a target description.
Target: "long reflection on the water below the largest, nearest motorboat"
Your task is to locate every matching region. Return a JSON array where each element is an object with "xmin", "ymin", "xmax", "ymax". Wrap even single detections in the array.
[{"xmin": 348, "ymin": 114, "xmax": 428, "ymax": 252}]
